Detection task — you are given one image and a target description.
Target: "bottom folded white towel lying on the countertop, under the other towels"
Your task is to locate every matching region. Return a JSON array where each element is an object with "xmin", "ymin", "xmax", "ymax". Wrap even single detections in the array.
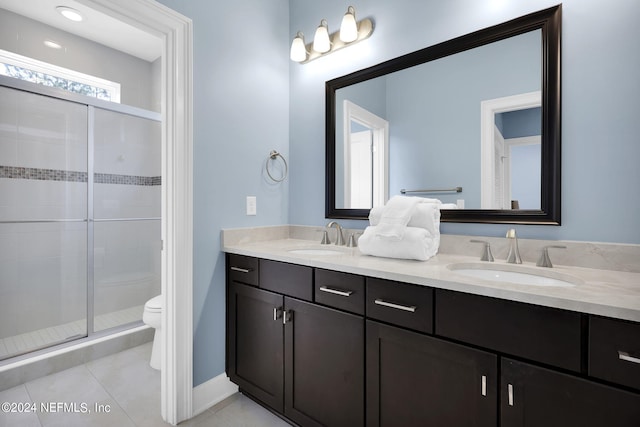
[{"xmin": 358, "ymin": 226, "xmax": 440, "ymax": 261}]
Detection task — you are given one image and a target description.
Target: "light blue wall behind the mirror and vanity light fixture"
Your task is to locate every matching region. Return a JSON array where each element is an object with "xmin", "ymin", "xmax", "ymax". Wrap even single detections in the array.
[{"xmin": 289, "ymin": 0, "xmax": 640, "ymax": 243}]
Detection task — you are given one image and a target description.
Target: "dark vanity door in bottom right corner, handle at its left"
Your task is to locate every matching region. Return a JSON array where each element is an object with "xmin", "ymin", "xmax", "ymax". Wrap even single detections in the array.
[{"xmin": 500, "ymin": 359, "xmax": 640, "ymax": 427}]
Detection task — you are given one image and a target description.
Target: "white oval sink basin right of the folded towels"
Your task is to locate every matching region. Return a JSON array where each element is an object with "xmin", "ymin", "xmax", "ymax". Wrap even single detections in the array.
[{"xmin": 447, "ymin": 263, "xmax": 582, "ymax": 287}]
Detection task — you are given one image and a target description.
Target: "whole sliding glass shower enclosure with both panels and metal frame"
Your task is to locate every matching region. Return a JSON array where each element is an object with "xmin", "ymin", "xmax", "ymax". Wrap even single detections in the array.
[{"xmin": 0, "ymin": 79, "xmax": 161, "ymax": 360}]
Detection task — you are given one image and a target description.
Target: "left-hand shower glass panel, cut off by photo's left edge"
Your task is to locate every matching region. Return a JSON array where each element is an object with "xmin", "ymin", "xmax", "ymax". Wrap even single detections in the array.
[{"xmin": 0, "ymin": 87, "xmax": 88, "ymax": 360}]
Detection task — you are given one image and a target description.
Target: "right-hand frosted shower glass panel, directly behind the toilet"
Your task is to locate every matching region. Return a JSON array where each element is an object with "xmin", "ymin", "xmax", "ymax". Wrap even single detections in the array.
[{"xmin": 89, "ymin": 108, "xmax": 161, "ymax": 331}]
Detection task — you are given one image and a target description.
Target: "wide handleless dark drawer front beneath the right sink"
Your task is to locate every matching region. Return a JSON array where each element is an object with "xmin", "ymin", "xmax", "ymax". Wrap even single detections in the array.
[{"xmin": 435, "ymin": 289, "xmax": 582, "ymax": 372}]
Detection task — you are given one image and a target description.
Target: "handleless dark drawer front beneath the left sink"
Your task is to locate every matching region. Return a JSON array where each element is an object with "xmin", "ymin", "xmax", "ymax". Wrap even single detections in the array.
[{"xmin": 260, "ymin": 259, "xmax": 313, "ymax": 301}]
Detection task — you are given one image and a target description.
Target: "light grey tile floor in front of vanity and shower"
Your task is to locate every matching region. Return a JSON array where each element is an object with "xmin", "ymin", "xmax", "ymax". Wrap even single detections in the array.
[{"xmin": 0, "ymin": 343, "xmax": 289, "ymax": 427}]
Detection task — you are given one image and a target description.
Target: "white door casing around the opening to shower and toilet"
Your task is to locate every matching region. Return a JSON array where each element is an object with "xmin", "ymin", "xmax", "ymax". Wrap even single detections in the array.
[{"xmin": 77, "ymin": 0, "xmax": 193, "ymax": 425}]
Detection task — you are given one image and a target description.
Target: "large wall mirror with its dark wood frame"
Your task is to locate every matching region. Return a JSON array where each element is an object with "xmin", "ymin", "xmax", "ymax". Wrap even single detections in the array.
[{"xmin": 325, "ymin": 5, "xmax": 562, "ymax": 225}]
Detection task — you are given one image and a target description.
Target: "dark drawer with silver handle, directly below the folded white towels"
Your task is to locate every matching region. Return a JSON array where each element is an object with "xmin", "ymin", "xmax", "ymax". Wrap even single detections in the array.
[{"xmin": 367, "ymin": 277, "xmax": 433, "ymax": 334}]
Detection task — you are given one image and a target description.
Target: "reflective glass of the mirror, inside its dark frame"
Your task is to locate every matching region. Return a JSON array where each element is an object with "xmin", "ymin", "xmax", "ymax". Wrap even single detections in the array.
[{"xmin": 335, "ymin": 29, "xmax": 542, "ymax": 209}]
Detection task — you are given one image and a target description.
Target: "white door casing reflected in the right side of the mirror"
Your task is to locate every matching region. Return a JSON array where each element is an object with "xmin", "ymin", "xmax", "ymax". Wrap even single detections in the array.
[{"xmin": 480, "ymin": 91, "xmax": 542, "ymax": 209}]
